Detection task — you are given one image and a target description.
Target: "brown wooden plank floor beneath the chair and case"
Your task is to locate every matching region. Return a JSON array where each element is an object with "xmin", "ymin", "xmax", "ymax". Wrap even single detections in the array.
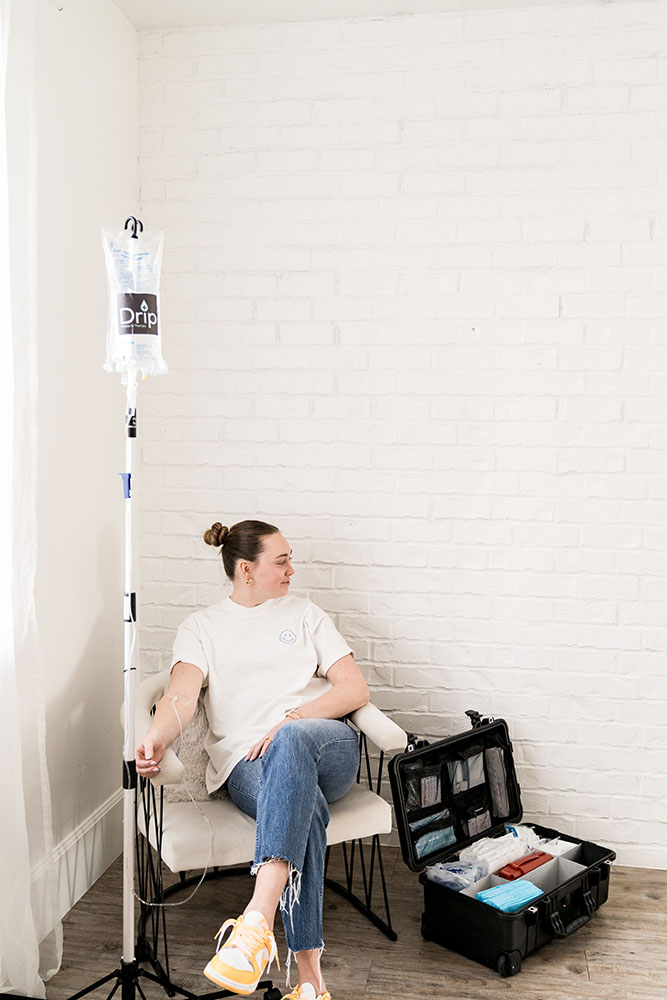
[{"xmin": 46, "ymin": 848, "xmax": 667, "ymax": 1000}]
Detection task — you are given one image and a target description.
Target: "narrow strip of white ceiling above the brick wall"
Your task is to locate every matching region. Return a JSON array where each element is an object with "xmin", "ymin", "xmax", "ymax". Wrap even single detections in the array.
[{"xmin": 115, "ymin": 0, "xmax": 604, "ymax": 30}]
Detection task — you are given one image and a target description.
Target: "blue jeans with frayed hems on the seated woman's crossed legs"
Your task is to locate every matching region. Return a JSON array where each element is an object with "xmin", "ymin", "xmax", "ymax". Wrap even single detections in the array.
[{"xmin": 227, "ymin": 719, "xmax": 359, "ymax": 952}]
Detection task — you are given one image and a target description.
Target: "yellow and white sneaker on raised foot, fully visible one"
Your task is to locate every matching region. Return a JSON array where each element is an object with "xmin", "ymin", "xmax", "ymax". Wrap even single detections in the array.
[{"xmin": 204, "ymin": 910, "xmax": 280, "ymax": 995}]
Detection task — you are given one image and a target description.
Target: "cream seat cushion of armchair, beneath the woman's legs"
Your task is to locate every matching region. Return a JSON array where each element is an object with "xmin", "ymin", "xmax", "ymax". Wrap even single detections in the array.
[{"xmin": 138, "ymin": 785, "xmax": 391, "ymax": 872}]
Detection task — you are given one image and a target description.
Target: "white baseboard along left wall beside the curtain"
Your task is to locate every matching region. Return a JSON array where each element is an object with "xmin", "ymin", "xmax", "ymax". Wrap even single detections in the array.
[{"xmin": 32, "ymin": 788, "xmax": 123, "ymax": 923}]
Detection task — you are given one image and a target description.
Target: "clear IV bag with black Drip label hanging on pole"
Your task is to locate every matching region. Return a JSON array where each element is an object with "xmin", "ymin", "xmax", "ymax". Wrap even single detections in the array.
[{"xmin": 102, "ymin": 220, "xmax": 167, "ymax": 385}]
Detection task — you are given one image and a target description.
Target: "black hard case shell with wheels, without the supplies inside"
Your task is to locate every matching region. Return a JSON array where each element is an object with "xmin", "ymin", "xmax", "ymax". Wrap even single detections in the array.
[{"xmin": 389, "ymin": 712, "xmax": 616, "ymax": 976}]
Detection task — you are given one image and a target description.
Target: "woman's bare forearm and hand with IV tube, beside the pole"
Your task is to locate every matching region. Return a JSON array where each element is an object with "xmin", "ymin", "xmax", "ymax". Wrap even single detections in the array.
[{"xmin": 135, "ymin": 660, "xmax": 204, "ymax": 778}]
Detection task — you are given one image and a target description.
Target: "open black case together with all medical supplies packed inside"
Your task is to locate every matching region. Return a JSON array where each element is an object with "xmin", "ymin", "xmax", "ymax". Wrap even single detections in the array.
[{"xmin": 389, "ymin": 712, "xmax": 616, "ymax": 976}]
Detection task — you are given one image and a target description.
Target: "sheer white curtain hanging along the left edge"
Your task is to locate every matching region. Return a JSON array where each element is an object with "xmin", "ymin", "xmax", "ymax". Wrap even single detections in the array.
[{"xmin": 0, "ymin": 0, "xmax": 62, "ymax": 997}]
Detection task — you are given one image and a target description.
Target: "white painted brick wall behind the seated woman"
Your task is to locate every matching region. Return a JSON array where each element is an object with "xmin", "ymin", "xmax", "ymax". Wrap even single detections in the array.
[{"xmin": 141, "ymin": 0, "xmax": 667, "ymax": 867}]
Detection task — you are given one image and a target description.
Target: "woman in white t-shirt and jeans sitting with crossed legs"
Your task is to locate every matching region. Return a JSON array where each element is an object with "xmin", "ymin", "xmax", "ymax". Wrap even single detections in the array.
[{"xmin": 136, "ymin": 521, "xmax": 369, "ymax": 1000}]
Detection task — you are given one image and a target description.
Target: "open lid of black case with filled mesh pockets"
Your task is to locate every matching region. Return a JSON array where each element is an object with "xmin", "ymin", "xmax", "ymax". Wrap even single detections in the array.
[{"xmin": 389, "ymin": 711, "xmax": 523, "ymax": 872}]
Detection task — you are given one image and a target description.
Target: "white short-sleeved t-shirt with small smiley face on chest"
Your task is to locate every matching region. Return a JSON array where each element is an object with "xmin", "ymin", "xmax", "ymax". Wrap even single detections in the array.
[{"xmin": 171, "ymin": 594, "xmax": 352, "ymax": 792}]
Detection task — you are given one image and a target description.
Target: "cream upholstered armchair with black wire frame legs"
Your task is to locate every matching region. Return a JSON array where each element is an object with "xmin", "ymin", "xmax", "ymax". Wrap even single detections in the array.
[{"xmin": 136, "ymin": 671, "xmax": 407, "ymax": 992}]
